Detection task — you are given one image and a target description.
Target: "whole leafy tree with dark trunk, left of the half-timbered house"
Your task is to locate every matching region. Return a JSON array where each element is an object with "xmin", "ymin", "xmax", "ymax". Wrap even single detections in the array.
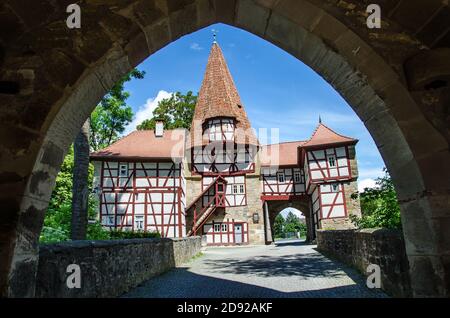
[{"xmin": 40, "ymin": 70, "xmax": 145, "ymax": 242}]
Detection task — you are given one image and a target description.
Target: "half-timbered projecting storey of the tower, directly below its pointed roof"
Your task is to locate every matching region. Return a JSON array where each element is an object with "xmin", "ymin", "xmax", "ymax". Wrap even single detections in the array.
[{"xmin": 191, "ymin": 142, "xmax": 256, "ymax": 176}]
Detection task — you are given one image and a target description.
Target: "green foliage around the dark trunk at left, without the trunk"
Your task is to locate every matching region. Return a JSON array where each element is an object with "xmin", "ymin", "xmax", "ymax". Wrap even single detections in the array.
[{"xmin": 40, "ymin": 69, "xmax": 145, "ymax": 243}]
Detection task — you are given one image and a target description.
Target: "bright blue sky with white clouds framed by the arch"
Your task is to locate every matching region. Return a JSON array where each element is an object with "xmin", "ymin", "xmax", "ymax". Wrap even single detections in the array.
[{"xmin": 126, "ymin": 24, "xmax": 384, "ymax": 191}]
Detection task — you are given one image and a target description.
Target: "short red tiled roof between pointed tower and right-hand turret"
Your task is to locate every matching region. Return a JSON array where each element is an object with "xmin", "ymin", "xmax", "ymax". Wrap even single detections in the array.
[{"xmin": 260, "ymin": 141, "xmax": 305, "ymax": 167}]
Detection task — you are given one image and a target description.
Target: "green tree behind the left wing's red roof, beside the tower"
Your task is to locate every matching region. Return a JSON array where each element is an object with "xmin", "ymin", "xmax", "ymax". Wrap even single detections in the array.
[{"xmin": 137, "ymin": 91, "xmax": 198, "ymax": 130}]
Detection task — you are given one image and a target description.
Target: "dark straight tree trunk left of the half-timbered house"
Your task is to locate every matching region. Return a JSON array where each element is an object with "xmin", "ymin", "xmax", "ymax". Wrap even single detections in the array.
[{"xmin": 71, "ymin": 119, "xmax": 89, "ymax": 240}]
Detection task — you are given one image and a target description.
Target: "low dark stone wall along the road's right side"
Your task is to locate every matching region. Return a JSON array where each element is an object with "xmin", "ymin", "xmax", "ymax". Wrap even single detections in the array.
[{"xmin": 317, "ymin": 229, "xmax": 411, "ymax": 297}]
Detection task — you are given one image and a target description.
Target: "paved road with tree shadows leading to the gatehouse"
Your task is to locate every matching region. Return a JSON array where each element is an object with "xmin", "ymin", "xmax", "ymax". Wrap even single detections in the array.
[{"xmin": 124, "ymin": 241, "xmax": 386, "ymax": 298}]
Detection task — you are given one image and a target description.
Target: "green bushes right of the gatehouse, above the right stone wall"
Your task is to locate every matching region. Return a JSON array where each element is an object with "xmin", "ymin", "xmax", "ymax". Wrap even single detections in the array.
[{"xmin": 350, "ymin": 169, "xmax": 401, "ymax": 229}]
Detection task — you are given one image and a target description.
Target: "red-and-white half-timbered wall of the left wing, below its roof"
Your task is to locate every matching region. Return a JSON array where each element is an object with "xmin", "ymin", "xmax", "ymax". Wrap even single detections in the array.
[{"xmin": 100, "ymin": 161, "xmax": 185, "ymax": 237}]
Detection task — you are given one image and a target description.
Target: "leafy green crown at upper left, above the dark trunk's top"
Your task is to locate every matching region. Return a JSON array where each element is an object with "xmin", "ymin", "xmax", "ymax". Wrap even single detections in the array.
[{"xmin": 90, "ymin": 69, "xmax": 145, "ymax": 151}]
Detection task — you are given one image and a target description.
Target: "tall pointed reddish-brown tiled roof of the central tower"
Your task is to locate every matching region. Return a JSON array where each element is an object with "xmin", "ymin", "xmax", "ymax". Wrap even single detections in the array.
[{"xmin": 191, "ymin": 42, "xmax": 258, "ymax": 146}]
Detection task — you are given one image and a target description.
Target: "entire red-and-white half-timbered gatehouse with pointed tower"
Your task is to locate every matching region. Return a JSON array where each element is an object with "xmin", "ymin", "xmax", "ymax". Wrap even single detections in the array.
[{"xmin": 91, "ymin": 43, "xmax": 360, "ymax": 245}]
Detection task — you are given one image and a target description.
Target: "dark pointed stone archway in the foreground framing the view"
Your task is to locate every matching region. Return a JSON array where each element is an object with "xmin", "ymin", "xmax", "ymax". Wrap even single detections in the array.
[{"xmin": 0, "ymin": 0, "xmax": 450, "ymax": 296}]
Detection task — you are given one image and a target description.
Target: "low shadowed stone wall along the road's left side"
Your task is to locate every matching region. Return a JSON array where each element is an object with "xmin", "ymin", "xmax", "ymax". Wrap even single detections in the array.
[{"xmin": 36, "ymin": 237, "xmax": 201, "ymax": 298}]
